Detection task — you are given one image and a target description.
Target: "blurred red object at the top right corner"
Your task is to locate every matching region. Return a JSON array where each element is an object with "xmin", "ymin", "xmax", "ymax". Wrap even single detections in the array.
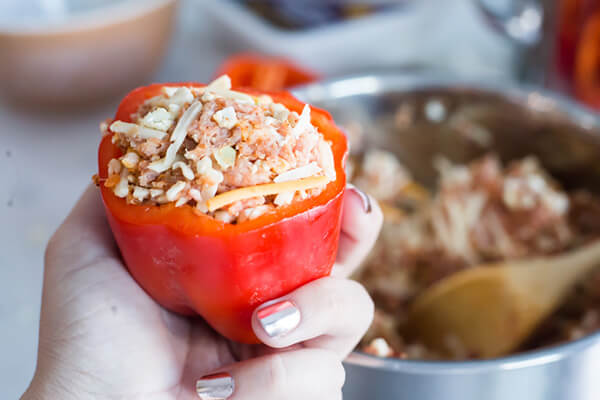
[{"xmin": 557, "ymin": 0, "xmax": 600, "ymax": 110}]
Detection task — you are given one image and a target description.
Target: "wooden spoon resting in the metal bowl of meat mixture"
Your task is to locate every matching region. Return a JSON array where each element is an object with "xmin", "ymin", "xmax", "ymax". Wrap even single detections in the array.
[{"xmin": 406, "ymin": 241, "xmax": 600, "ymax": 358}]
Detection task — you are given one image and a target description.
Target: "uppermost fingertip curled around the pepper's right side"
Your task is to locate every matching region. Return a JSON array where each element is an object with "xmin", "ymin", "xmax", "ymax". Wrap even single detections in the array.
[{"xmin": 333, "ymin": 184, "xmax": 383, "ymax": 277}]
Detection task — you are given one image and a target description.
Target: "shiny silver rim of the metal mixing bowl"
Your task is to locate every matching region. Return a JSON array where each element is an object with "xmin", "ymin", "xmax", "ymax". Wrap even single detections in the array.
[{"xmin": 292, "ymin": 69, "xmax": 600, "ymax": 375}]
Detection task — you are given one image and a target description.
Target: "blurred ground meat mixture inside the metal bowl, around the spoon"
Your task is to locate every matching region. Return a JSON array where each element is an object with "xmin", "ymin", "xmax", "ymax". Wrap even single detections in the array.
[{"xmin": 352, "ymin": 150, "xmax": 600, "ymax": 360}]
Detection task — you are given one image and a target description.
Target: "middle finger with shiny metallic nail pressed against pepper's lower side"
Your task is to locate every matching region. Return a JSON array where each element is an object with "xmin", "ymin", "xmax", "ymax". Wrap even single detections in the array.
[{"xmin": 252, "ymin": 277, "xmax": 373, "ymax": 359}]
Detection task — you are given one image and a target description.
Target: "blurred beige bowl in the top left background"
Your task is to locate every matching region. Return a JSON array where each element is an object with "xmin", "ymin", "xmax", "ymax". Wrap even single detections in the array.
[{"xmin": 0, "ymin": 0, "xmax": 177, "ymax": 105}]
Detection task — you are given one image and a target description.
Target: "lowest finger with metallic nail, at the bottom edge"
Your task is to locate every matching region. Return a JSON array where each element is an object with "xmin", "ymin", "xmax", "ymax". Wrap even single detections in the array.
[{"xmin": 196, "ymin": 349, "xmax": 345, "ymax": 400}]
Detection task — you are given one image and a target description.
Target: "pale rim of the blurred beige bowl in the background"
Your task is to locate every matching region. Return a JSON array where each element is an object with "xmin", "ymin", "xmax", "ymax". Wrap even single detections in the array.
[{"xmin": 0, "ymin": 0, "xmax": 179, "ymax": 36}]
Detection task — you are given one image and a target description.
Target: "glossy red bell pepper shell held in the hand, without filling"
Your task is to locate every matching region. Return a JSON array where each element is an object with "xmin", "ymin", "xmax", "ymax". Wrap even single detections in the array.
[{"xmin": 98, "ymin": 83, "xmax": 347, "ymax": 343}]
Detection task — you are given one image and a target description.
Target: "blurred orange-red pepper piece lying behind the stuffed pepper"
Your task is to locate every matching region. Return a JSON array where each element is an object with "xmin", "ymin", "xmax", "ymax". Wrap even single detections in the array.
[{"xmin": 216, "ymin": 54, "xmax": 319, "ymax": 91}]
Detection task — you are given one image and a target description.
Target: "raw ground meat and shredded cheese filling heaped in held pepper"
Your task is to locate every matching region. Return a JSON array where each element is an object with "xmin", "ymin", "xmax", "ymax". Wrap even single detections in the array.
[{"xmin": 104, "ymin": 76, "xmax": 336, "ymax": 223}]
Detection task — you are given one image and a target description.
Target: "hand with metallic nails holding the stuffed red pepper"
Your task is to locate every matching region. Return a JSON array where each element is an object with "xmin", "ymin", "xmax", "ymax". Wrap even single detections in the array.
[{"xmin": 22, "ymin": 188, "xmax": 382, "ymax": 400}]
